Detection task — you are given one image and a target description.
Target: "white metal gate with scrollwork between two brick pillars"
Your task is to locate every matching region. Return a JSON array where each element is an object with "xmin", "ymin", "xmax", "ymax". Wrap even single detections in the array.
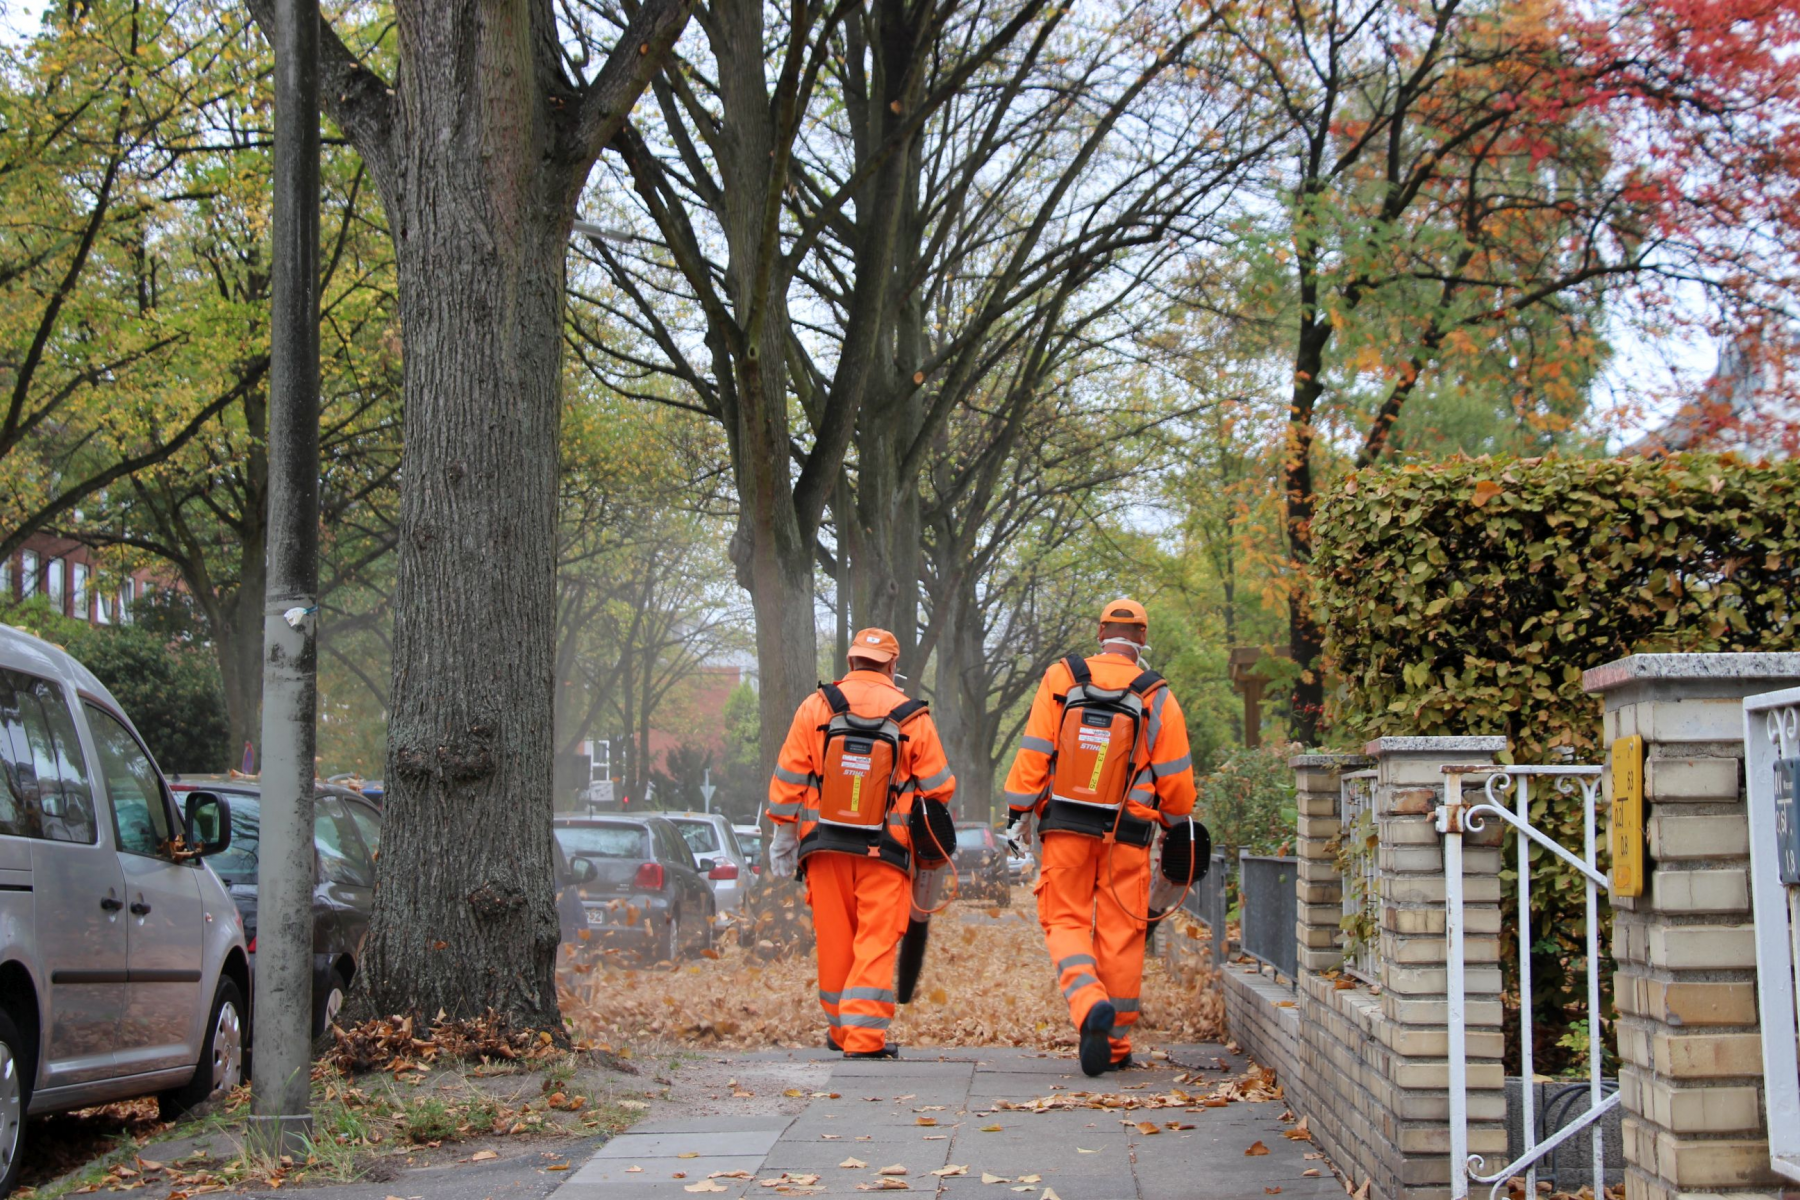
[{"xmin": 1438, "ymin": 766, "xmax": 1620, "ymax": 1200}]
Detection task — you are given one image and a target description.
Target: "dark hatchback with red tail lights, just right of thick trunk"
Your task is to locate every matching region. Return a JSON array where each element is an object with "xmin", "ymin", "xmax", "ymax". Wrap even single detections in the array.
[{"xmin": 556, "ymin": 813, "xmax": 718, "ymax": 961}]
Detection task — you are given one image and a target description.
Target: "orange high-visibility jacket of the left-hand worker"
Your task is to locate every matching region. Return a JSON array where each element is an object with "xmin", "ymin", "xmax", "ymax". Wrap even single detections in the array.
[{"xmin": 769, "ymin": 671, "xmax": 956, "ymax": 865}]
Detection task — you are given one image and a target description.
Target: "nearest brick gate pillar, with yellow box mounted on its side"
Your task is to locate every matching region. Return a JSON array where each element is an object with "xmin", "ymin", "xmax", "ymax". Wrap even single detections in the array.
[{"xmin": 1582, "ymin": 653, "xmax": 1800, "ymax": 1200}]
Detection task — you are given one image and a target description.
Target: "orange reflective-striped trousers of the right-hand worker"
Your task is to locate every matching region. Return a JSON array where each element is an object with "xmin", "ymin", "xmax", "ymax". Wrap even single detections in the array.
[{"xmin": 1037, "ymin": 833, "xmax": 1150, "ymax": 1061}]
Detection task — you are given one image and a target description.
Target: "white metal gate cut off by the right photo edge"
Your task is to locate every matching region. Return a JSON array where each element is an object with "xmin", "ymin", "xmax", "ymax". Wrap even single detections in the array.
[{"xmin": 1744, "ymin": 687, "xmax": 1800, "ymax": 1180}]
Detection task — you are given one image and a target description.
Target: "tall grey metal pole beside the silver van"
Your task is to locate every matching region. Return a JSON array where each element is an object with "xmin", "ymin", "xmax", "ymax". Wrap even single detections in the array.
[{"xmin": 248, "ymin": 0, "xmax": 319, "ymax": 1153}]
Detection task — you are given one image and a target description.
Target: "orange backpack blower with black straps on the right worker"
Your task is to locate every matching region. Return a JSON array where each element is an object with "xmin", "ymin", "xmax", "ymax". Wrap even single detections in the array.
[{"xmin": 1037, "ymin": 655, "xmax": 1165, "ymax": 846}]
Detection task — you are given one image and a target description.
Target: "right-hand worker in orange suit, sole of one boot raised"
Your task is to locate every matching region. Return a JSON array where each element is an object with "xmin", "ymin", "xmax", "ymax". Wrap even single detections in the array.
[{"xmin": 1006, "ymin": 599, "xmax": 1193, "ymax": 1076}]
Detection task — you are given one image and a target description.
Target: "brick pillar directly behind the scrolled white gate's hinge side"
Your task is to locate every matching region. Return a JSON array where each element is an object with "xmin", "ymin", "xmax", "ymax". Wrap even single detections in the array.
[{"xmin": 1366, "ymin": 738, "xmax": 1507, "ymax": 1200}]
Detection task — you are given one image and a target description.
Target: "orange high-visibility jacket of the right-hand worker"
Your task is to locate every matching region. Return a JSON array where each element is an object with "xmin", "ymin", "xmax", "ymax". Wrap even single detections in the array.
[{"xmin": 1006, "ymin": 655, "xmax": 1193, "ymax": 840}]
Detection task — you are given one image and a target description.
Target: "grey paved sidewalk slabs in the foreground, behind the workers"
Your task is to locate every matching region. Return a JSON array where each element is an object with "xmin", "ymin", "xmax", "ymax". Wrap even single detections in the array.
[{"xmin": 554, "ymin": 1045, "xmax": 1343, "ymax": 1200}]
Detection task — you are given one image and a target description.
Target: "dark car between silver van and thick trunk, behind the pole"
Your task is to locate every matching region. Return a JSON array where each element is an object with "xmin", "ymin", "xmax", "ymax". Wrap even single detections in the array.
[{"xmin": 169, "ymin": 775, "xmax": 382, "ymax": 1036}]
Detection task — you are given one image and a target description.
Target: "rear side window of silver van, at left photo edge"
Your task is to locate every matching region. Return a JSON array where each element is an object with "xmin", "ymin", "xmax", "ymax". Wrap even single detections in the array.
[{"xmin": 0, "ymin": 671, "xmax": 97, "ymax": 844}]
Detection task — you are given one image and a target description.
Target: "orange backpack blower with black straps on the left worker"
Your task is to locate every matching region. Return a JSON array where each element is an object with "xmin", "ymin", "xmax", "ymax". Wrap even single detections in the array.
[{"xmin": 799, "ymin": 684, "xmax": 927, "ymax": 871}]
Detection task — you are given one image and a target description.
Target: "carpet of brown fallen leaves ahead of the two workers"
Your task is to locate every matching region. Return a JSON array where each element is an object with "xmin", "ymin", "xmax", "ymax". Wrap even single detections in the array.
[{"xmin": 562, "ymin": 889, "xmax": 1224, "ymax": 1051}]
